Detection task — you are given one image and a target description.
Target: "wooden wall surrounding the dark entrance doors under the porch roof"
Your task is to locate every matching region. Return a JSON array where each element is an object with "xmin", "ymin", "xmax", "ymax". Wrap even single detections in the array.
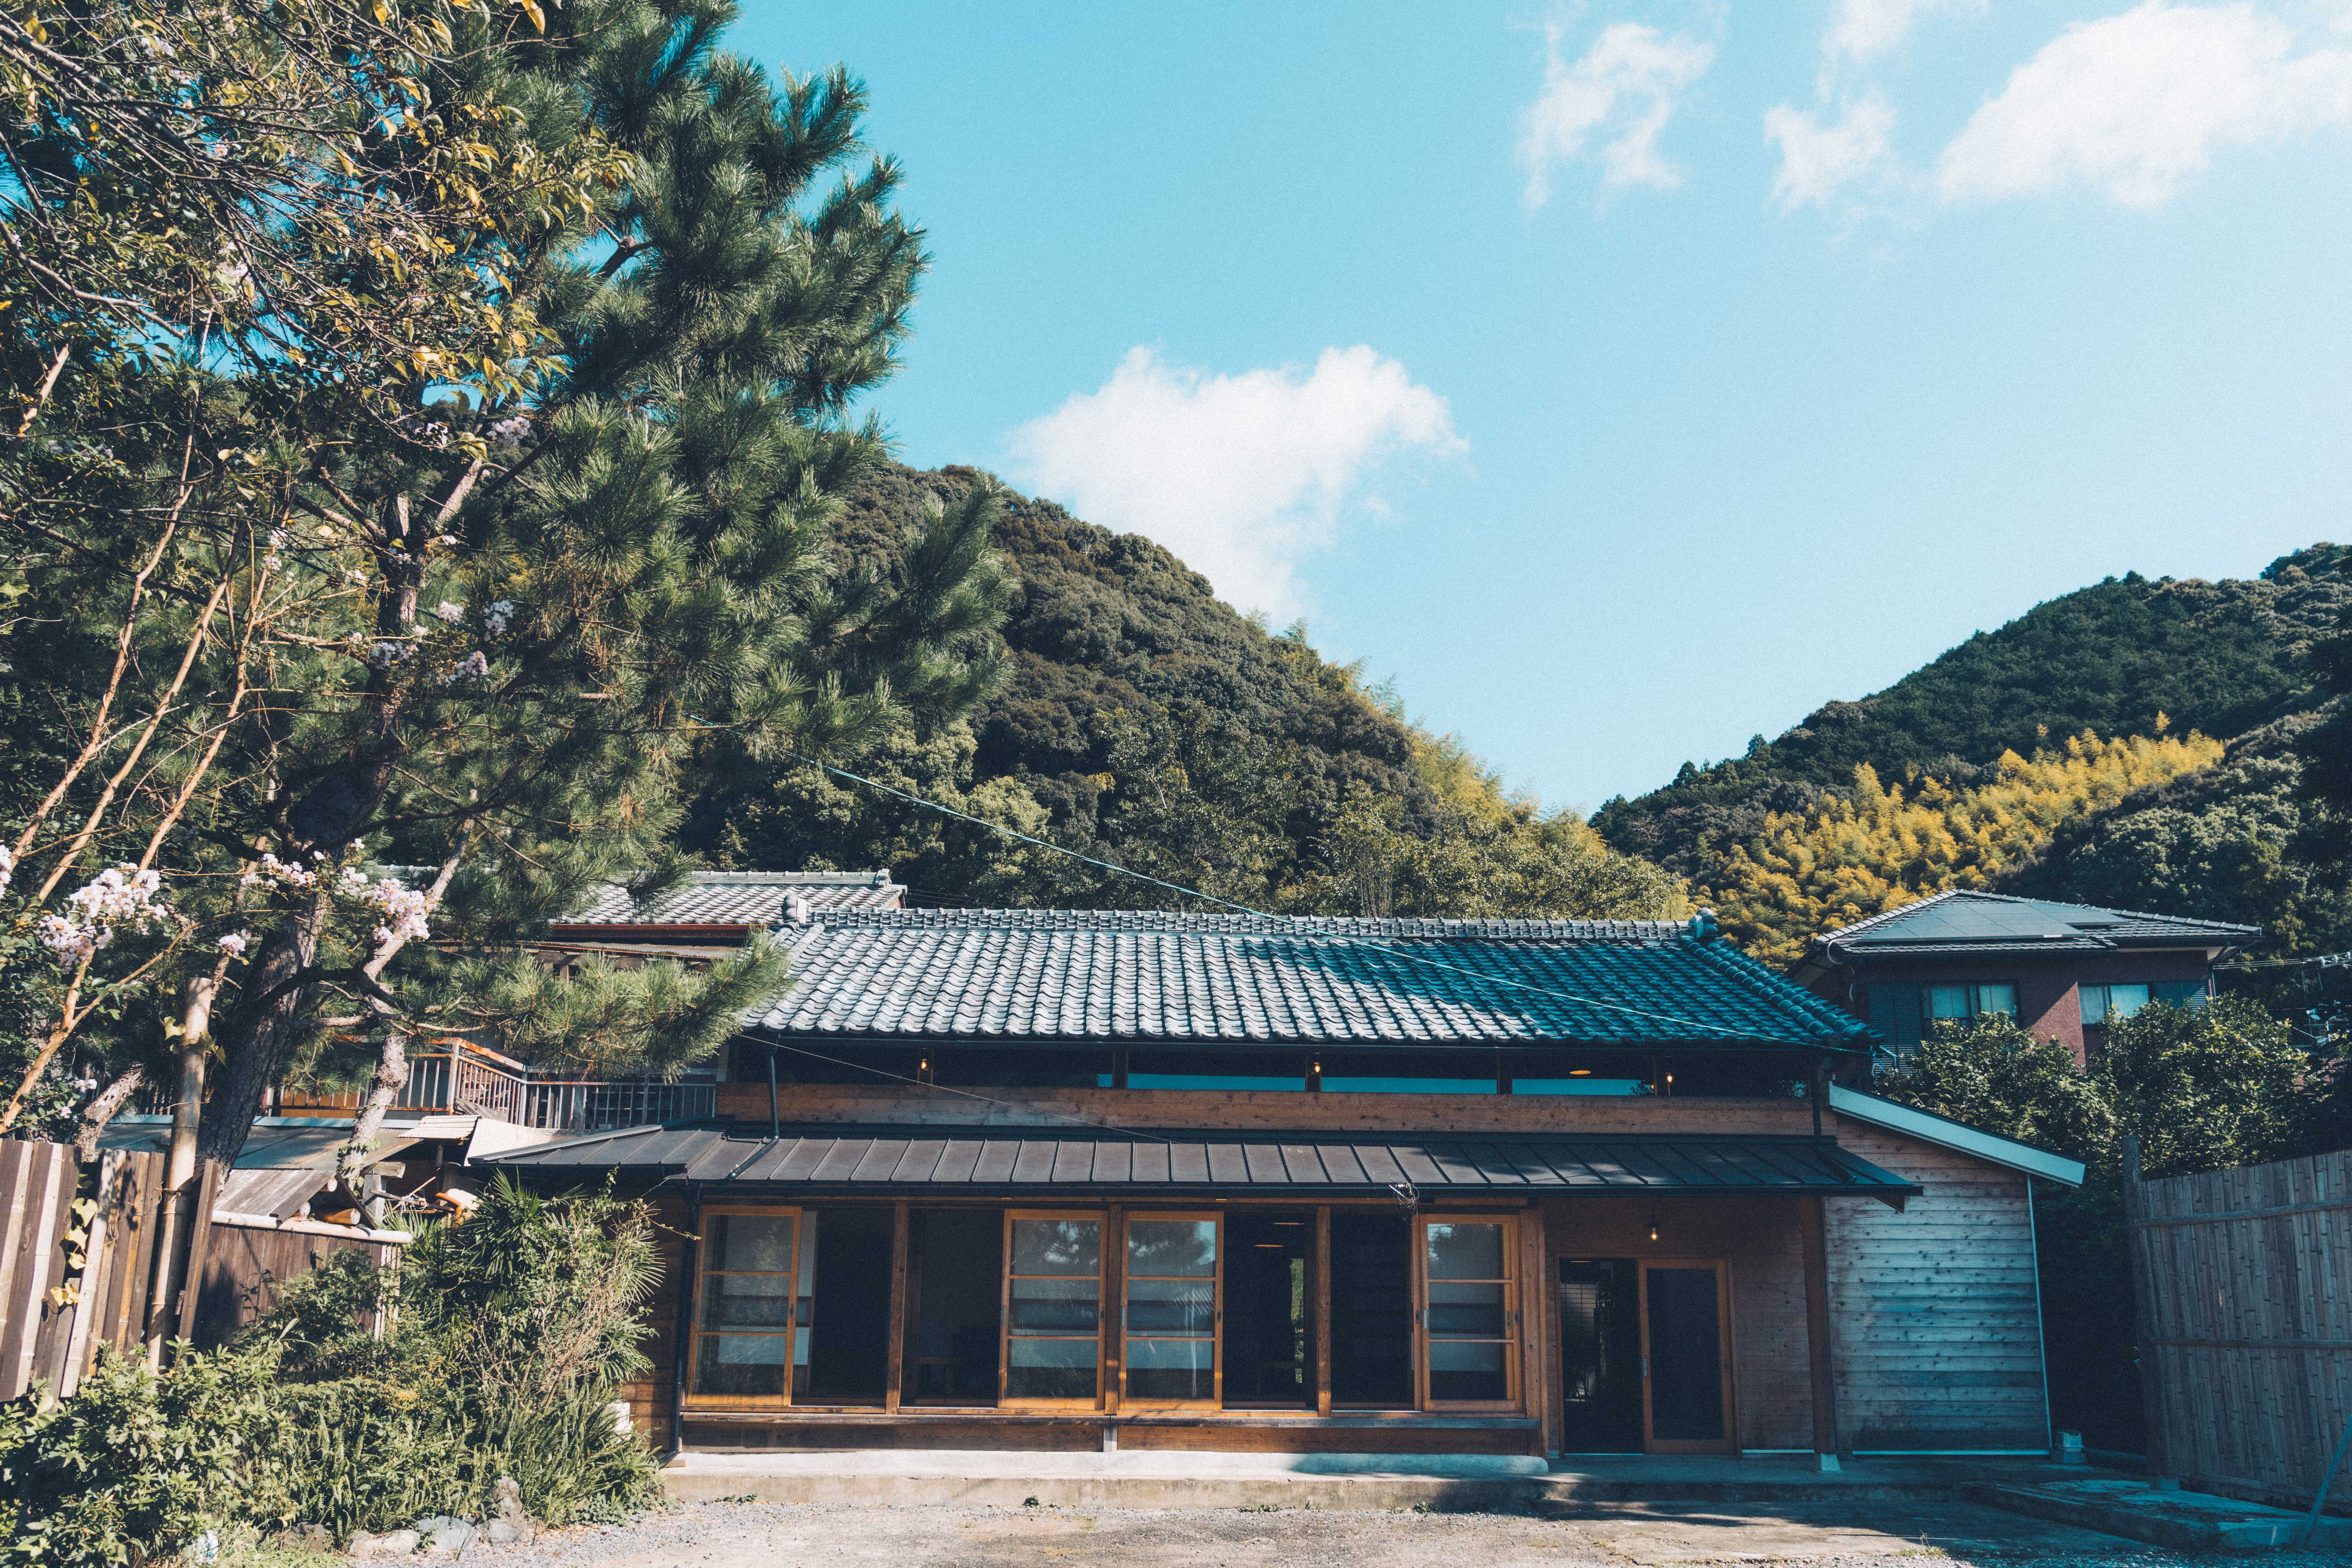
[{"xmin": 1543, "ymin": 1194, "xmax": 1814, "ymax": 1448}]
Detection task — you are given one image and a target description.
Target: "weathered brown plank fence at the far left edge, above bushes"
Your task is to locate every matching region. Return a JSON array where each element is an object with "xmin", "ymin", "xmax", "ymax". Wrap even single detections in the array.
[{"xmin": 0, "ymin": 1138, "xmax": 165, "ymax": 1399}]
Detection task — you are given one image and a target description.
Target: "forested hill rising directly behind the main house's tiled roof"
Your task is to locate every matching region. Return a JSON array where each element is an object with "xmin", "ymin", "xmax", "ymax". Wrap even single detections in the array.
[{"xmin": 687, "ymin": 465, "xmax": 1687, "ymax": 917}]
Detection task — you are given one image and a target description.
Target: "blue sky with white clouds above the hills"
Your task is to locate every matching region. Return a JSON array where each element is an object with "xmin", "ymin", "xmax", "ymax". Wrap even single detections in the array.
[{"xmin": 734, "ymin": 0, "xmax": 2352, "ymax": 809}]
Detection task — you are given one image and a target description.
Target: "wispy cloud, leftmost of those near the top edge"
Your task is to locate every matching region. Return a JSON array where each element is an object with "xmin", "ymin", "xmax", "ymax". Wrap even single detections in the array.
[{"xmin": 1519, "ymin": 21, "xmax": 1715, "ymax": 207}]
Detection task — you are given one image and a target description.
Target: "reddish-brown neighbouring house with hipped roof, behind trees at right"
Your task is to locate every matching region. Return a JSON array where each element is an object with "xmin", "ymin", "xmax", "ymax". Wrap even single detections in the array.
[{"xmin": 1788, "ymin": 891, "xmax": 2262, "ymax": 1062}]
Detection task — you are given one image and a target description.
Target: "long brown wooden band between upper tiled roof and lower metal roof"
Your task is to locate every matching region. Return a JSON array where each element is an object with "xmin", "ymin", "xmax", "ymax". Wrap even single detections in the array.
[{"xmin": 718, "ymin": 1082, "xmax": 1814, "ymax": 1138}]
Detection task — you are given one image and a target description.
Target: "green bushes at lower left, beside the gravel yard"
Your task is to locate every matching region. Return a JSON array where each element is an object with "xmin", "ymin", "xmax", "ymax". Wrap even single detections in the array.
[{"xmin": 0, "ymin": 1180, "xmax": 659, "ymax": 1566}]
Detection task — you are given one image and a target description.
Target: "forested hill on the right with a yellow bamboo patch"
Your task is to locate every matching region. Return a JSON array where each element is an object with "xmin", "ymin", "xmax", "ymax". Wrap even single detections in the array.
[{"xmin": 1592, "ymin": 545, "xmax": 2352, "ymax": 959}]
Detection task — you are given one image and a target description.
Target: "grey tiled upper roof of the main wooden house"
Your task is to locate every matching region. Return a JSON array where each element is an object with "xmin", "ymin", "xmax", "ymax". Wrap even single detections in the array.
[{"xmin": 746, "ymin": 910, "xmax": 1875, "ymax": 1049}]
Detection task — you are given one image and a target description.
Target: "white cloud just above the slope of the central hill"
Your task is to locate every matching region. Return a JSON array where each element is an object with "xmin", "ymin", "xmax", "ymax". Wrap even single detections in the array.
[{"xmin": 1011, "ymin": 346, "xmax": 1465, "ymax": 616}]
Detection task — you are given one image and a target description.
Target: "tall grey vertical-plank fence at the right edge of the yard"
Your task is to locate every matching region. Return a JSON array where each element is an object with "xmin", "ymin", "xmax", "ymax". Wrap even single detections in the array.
[{"xmin": 2124, "ymin": 1147, "xmax": 2352, "ymax": 1511}]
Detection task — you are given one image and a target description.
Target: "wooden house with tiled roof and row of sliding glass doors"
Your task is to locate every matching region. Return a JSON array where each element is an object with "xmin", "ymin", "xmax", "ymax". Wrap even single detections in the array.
[{"xmin": 477, "ymin": 910, "xmax": 2081, "ymax": 1455}]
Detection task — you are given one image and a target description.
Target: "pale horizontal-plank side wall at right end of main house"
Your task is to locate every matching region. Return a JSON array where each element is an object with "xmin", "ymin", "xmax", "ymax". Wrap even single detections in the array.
[{"xmin": 1799, "ymin": 1119, "xmax": 2051, "ymax": 1450}]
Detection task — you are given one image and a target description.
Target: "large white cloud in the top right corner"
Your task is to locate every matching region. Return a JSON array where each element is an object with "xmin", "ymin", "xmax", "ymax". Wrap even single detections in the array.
[{"xmin": 1936, "ymin": 0, "xmax": 2352, "ymax": 209}]
